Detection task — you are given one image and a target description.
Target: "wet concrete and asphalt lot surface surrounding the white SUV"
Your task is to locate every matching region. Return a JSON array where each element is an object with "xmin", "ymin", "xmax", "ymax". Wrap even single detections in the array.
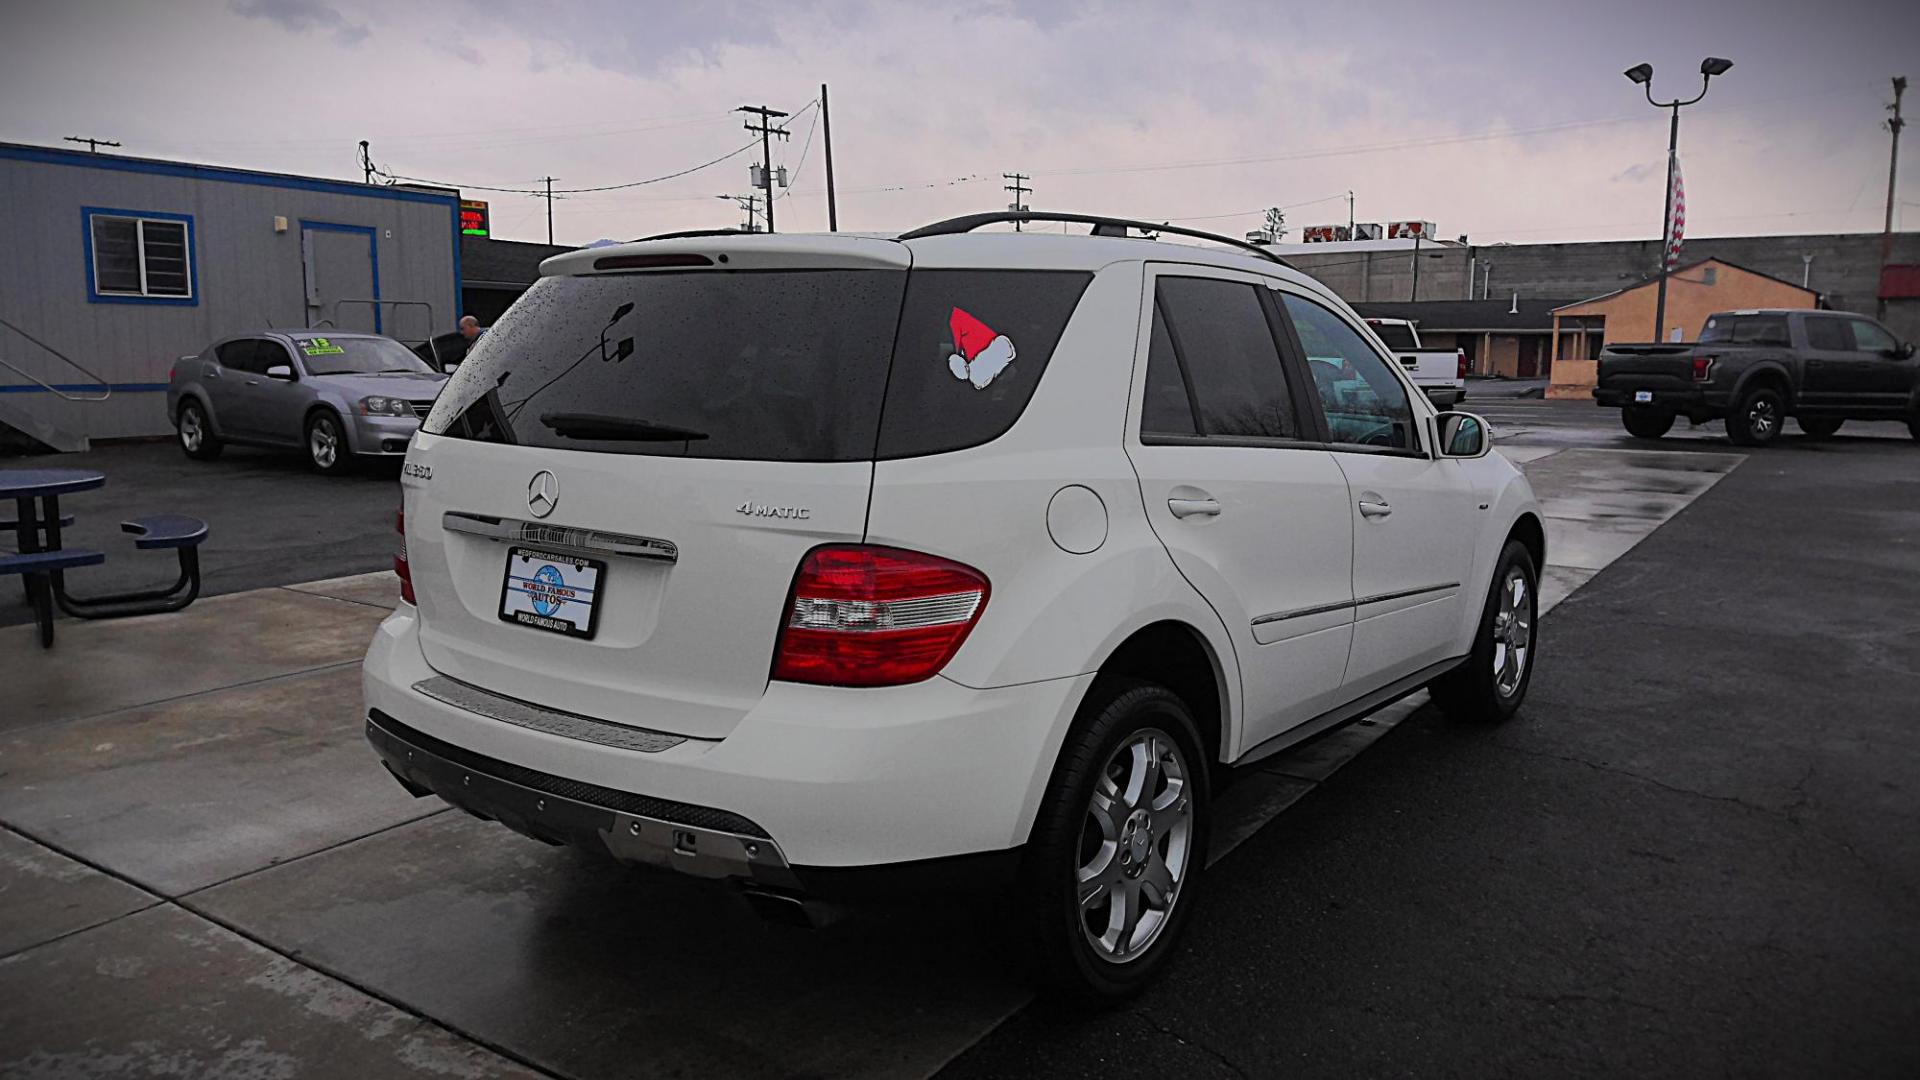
[{"xmin": 0, "ymin": 398, "xmax": 1920, "ymax": 1080}]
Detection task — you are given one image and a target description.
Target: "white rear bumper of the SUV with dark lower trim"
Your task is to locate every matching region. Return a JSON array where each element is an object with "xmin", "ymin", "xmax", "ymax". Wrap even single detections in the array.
[{"xmin": 363, "ymin": 607, "xmax": 1092, "ymax": 880}]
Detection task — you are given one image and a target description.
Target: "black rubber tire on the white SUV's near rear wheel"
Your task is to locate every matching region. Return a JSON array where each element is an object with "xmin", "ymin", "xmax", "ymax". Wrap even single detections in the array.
[{"xmin": 1020, "ymin": 678, "xmax": 1212, "ymax": 1001}]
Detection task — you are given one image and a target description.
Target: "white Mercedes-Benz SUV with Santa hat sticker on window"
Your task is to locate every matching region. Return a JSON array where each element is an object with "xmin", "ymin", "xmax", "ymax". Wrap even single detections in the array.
[{"xmin": 365, "ymin": 213, "xmax": 1546, "ymax": 995}]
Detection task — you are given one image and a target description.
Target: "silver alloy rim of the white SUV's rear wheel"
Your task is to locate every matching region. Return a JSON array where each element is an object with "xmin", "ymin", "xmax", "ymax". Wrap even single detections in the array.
[{"xmin": 1075, "ymin": 728, "xmax": 1194, "ymax": 963}]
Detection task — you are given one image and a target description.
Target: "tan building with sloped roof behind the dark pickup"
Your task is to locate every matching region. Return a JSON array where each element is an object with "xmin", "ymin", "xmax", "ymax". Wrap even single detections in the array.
[{"xmin": 1548, "ymin": 259, "xmax": 1818, "ymax": 398}]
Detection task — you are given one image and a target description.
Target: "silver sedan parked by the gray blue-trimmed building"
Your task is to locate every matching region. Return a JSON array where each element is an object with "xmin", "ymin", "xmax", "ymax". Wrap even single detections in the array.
[{"xmin": 167, "ymin": 331, "xmax": 447, "ymax": 473}]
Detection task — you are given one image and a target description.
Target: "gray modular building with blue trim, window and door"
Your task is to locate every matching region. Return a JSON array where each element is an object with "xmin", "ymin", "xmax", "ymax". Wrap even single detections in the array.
[{"xmin": 0, "ymin": 142, "xmax": 461, "ymax": 450}]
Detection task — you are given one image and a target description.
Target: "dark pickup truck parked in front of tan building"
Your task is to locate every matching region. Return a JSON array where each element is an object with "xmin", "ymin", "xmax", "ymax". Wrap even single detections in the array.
[{"xmin": 1594, "ymin": 309, "xmax": 1920, "ymax": 446}]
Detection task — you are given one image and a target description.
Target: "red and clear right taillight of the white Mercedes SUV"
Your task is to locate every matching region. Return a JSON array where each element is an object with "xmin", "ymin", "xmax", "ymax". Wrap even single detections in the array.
[{"xmin": 774, "ymin": 544, "xmax": 989, "ymax": 686}]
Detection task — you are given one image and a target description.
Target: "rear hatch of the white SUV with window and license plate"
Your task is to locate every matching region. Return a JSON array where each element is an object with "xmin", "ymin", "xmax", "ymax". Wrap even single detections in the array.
[{"xmin": 405, "ymin": 236, "xmax": 908, "ymax": 738}]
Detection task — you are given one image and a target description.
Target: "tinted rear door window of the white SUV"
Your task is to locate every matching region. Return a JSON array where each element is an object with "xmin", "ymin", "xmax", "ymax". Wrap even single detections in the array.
[{"xmin": 1140, "ymin": 277, "xmax": 1300, "ymax": 438}]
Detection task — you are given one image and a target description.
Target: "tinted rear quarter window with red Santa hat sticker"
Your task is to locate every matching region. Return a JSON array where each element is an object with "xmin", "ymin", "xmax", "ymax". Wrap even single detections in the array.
[{"xmin": 876, "ymin": 269, "xmax": 1092, "ymax": 459}]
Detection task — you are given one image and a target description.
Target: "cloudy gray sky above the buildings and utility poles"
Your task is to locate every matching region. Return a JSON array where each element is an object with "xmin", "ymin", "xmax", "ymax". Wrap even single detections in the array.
[{"xmin": 0, "ymin": 0, "xmax": 1920, "ymax": 244}]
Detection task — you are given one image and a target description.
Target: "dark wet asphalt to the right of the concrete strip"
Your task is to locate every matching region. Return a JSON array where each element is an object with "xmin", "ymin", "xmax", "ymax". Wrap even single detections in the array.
[{"xmin": 941, "ymin": 426, "xmax": 1920, "ymax": 1080}]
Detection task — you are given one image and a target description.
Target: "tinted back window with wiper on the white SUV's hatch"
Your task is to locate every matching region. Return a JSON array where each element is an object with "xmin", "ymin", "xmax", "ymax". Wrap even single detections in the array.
[{"xmin": 424, "ymin": 269, "xmax": 910, "ymax": 461}]
